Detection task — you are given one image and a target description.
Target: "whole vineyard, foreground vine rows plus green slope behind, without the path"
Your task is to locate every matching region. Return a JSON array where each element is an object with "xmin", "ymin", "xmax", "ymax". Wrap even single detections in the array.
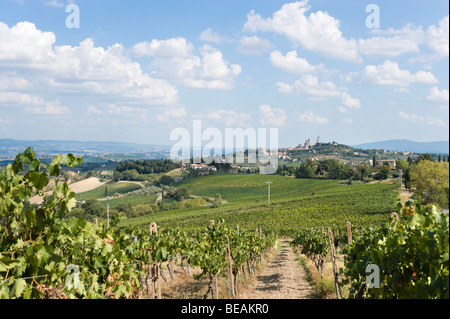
[{"xmin": 0, "ymin": 149, "xmax": 449, "ymax": 299}]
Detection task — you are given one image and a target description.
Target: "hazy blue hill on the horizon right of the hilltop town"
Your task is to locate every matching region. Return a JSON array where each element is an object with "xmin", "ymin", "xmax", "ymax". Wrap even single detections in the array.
[{"xmin": 352, "ymin": 140, "xmax": 449, "ymax": 154}]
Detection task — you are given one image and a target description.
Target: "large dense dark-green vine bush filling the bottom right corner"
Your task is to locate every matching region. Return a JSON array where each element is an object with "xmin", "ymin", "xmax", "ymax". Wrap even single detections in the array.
[{"xmin": 343, "ymin": 202, "xmax": 449, "ymax": 299}]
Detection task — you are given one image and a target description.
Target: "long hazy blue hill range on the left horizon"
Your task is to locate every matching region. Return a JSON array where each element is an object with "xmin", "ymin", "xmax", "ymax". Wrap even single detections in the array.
[{"xmin": 0, "ymin": 139, "xmax": 170, "ymax": 158}]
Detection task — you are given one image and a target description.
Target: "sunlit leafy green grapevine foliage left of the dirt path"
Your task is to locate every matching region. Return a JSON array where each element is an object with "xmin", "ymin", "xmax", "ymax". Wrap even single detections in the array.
[{"xmin": 0, "ymin": 149, "xmax": 275, "ymax": 299}]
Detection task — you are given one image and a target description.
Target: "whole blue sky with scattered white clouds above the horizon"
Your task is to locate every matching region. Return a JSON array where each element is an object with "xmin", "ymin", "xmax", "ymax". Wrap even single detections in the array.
[{"xmin": 0, "ymin": 0, "xmax": 449, "ymax": 146}]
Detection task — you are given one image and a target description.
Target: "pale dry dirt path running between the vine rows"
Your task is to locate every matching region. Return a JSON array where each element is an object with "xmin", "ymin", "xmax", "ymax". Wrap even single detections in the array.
[{"xmin": 241, "ymin": 239, "xmax": 311, "ymax": 299}]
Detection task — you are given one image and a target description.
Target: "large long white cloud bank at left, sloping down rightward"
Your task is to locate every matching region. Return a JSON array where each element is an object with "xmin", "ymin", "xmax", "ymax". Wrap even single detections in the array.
[{"xmin": 0, "ymin": 22, "xmax": 178, "ymax": 104}]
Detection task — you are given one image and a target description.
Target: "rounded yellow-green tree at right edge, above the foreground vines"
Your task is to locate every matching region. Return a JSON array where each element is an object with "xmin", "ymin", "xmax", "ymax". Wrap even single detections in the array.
[{"xmin": 411, "ymin": 160, "xmax": 449, "ymax": 208}]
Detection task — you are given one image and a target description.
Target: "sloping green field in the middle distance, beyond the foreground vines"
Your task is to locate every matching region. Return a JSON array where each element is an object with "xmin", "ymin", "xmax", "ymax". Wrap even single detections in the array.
[{"xmin": 121, "ymin": 175, "xmax": 399, "ymax": 234}]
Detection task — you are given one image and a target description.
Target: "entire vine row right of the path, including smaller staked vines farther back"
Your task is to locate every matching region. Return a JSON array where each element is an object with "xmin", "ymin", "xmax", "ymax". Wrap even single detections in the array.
[{"xmin": 291, "ymin": 202, "xmax": 449, "ymax": 299}]
